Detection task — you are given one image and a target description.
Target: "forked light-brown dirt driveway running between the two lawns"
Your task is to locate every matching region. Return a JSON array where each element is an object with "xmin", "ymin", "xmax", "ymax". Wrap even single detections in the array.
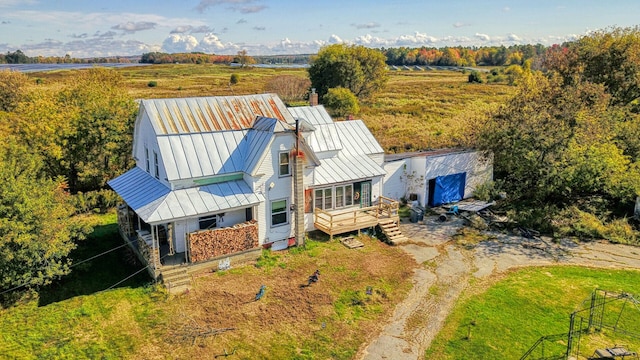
[{"xmin": 358, "ymin": 218, "xmax": 640, "ymax": 360}]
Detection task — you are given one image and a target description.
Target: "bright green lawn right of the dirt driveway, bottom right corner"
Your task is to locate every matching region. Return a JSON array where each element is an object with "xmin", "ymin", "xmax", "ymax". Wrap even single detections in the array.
[{"xmin": 426, "ymin": 267, "xmax": 640, "ymax": 359}]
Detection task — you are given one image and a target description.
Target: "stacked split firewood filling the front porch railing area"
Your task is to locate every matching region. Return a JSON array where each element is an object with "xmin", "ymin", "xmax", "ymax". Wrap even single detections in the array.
[{"xmin": 188, "ymin": 220, "xmax": 258, "ymax": 262}]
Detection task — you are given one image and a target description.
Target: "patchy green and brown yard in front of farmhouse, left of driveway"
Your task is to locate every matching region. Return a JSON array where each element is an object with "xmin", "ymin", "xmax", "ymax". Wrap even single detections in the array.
[{"xmin": 0, "ymin": 214, "xmax": 417, "ymax": 359}]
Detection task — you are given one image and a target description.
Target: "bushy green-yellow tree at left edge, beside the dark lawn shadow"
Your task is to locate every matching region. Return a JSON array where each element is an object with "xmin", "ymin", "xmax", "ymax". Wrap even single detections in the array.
[{"xmin": 0, "ymin": 137, "xmax": 84, "ymax": 300}]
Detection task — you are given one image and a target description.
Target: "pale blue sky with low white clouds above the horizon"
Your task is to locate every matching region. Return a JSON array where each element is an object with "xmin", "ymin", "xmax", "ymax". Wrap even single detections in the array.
[{"xmin": 0, "ymin": 0, "xmax": 640, "ymax": 57}]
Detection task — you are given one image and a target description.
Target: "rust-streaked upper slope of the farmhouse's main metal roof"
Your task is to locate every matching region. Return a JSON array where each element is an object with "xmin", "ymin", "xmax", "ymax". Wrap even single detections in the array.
[{"xmin": 140, "ymin": 94, "xmax": 295, "ymax": 135}]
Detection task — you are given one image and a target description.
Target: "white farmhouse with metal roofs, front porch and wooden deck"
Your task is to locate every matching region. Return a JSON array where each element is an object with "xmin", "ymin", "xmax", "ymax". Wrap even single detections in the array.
[{"xmin": 109, "ymin": 94, "xmax": 398, "ymax": 290}]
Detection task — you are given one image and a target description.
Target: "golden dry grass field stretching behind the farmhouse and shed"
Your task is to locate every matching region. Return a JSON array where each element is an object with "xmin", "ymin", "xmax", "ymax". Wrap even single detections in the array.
[{"xmin": 30, "ymin": 64, "xmax": 514, "ymax": 152}]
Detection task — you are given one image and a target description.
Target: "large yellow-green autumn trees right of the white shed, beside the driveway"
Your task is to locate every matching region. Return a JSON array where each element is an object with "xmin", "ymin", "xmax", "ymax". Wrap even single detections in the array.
[{"xmin": 476, "ymin": 28, "xmax": 640, "ymax": 242}]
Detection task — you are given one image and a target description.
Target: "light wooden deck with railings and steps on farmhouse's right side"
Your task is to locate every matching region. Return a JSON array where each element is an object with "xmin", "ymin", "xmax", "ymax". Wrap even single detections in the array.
[{"xmin": 313, "ymin": 196, "xmax": 400, "ymax": 240}]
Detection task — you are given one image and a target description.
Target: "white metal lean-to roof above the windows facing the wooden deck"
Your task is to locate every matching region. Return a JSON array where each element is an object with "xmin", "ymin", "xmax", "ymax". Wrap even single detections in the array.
[{"xmin": 313, "ymin": 155, "xmax": 386, "ymax": 186}]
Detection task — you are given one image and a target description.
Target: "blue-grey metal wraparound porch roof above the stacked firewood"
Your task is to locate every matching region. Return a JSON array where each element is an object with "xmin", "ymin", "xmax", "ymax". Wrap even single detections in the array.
[{"xmin": 109, "ymin": 167, "xmax": 264, "ymax": 224}]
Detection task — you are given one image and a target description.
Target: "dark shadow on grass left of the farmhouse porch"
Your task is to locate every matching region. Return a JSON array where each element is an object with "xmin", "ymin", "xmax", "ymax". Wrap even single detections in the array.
[{"xmin": 38, "ymin": 224, "xmax": 151, "ymax": 306}]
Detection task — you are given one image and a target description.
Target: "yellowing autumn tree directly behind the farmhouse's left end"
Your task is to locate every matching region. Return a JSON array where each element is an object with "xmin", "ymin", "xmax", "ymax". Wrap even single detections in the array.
[{"xmin": 7, "ymin": 68, "xmax": 137, "ymax": 193}]
